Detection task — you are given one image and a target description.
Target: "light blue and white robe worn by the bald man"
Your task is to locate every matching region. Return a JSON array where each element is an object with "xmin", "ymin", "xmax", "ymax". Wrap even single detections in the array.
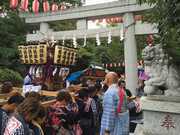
[{"xmin": 100, "ymin": 84, "xmax": 129, "ymax": 135}]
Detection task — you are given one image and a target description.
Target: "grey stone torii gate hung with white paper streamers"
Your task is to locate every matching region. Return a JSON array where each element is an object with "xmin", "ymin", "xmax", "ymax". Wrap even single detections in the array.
[{"xmin": 20, "ymin": 0, "xmax": 158, "ymax": 94}]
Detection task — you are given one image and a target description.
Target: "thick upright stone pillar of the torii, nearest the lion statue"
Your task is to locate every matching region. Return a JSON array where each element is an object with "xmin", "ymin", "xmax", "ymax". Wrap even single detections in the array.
[{"xmin": 123, "ymin": 13, "xmax": 138, "ymax": 95}]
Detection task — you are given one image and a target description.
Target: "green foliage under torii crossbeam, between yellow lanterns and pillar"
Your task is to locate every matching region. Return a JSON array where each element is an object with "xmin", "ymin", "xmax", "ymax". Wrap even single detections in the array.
[{"xmin": 76, "ymin": 37, "xmax": 124, "ymax": 65}]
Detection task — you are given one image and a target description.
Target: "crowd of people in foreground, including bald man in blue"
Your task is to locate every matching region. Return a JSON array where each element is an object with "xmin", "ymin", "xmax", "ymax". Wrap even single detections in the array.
[{"xmin": 0, "ymin": 72, "xmax": 143, "ymax": 135}]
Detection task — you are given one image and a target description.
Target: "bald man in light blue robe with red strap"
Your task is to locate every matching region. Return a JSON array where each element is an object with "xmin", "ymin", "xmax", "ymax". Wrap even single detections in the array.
[{"xmin": 100, "ymin": 72, "xmax": 129, "ymax": 135}]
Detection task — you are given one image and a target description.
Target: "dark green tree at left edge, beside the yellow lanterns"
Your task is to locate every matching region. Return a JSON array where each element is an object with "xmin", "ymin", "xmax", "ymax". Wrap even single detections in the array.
[{"xmin": 0, "ymin": 11, "xmax": 27, "ymax": 73}]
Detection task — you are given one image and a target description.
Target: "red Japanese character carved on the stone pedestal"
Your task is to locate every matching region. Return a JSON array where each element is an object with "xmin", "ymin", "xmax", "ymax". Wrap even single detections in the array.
[{"xmin": 161, "ymin": 114, "xmax": 175, "ymax": 130}]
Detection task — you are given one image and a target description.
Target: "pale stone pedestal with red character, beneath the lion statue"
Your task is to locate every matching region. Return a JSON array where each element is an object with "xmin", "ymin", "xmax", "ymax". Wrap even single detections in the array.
[{"xmin": 135, "ymin": 95, "xmax": 180, "ymax": 135}]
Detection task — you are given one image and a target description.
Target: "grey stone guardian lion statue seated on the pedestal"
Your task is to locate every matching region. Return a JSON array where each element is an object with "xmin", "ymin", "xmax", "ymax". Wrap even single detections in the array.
[{"xmin": 142, "ymin": 45, "xmax": 180, "ymax": 96}]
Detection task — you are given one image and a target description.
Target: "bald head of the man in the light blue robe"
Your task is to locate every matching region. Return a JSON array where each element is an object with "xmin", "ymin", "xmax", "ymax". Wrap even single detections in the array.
[{"xmin": 104, "ymin": 72, "xmax": 118, "ymax": 86}]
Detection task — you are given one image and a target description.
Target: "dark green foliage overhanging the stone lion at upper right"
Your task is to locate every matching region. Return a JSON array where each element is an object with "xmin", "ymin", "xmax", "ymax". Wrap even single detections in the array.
[{"xmin": 138, "ymin": 0, "xmax": 180, "ymax": 64}]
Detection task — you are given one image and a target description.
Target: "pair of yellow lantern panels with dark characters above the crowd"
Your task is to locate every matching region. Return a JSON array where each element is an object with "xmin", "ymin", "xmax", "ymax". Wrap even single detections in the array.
[{"xmin": 18, "ymin": 43, "xmax": 77, "ymax": 66}]
